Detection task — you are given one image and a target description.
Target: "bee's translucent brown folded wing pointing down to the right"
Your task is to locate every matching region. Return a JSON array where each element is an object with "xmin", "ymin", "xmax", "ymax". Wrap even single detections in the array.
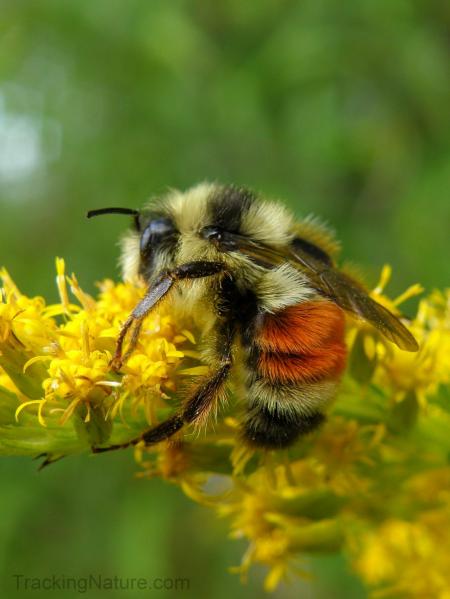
[{"xmin": 232, "ymin": 239, "xmax": 419, "ymax": 352}]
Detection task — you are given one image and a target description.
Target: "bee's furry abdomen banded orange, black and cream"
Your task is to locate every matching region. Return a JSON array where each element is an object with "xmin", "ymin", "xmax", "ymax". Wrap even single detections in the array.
[{"xmin": 243, "ymin": 300, "xmax": 346, "ymax": 449}]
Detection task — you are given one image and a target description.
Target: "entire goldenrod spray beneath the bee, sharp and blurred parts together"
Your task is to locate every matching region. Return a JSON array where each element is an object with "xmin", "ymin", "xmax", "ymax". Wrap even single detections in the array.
[{"xmin": 0, "ymin": 260, "xmax": 450, "ymax": 599}]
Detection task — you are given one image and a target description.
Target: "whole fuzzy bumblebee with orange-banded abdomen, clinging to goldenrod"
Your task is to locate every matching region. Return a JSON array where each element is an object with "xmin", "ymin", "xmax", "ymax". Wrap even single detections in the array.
[{"xmin": 88, "ymin": 183, "xmax": 418, "ymax": 451}]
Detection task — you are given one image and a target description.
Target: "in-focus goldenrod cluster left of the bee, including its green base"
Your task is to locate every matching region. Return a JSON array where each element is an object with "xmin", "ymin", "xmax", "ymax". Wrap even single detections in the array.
[{"xmin": 0, "ymin": 259, "xmax": 200, "ymax": 461}]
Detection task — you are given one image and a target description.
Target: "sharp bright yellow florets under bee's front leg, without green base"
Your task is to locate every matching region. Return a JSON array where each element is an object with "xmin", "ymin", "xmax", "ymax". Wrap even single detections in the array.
[{"xmin": 0, "ymin": 259, "xmax": 200, "ymax": 449}]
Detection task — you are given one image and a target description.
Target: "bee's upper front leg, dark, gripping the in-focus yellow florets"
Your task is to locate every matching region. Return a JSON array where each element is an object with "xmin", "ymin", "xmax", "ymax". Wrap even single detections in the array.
[{"xmin": 111, "ymin": 261, "xmax": 225, "ymax": 372}]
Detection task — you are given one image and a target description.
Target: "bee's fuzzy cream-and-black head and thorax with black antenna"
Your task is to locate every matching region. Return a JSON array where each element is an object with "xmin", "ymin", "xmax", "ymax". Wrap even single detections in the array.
[{"xmin": 88, "ymin": 183, "xmax": 293, "ymax": 282}]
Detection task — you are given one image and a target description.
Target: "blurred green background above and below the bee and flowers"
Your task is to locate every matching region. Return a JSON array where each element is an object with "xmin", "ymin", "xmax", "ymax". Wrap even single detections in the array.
[{"xmin": 0, "ymin": 0, "xmax": 450, "ymax": 599}]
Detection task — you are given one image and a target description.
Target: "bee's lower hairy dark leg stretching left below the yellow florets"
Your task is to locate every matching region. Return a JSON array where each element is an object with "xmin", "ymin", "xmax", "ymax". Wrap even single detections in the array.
[{"xmin": 92, "ymin": 322, "xmax": 234, "ymax": 453}]
